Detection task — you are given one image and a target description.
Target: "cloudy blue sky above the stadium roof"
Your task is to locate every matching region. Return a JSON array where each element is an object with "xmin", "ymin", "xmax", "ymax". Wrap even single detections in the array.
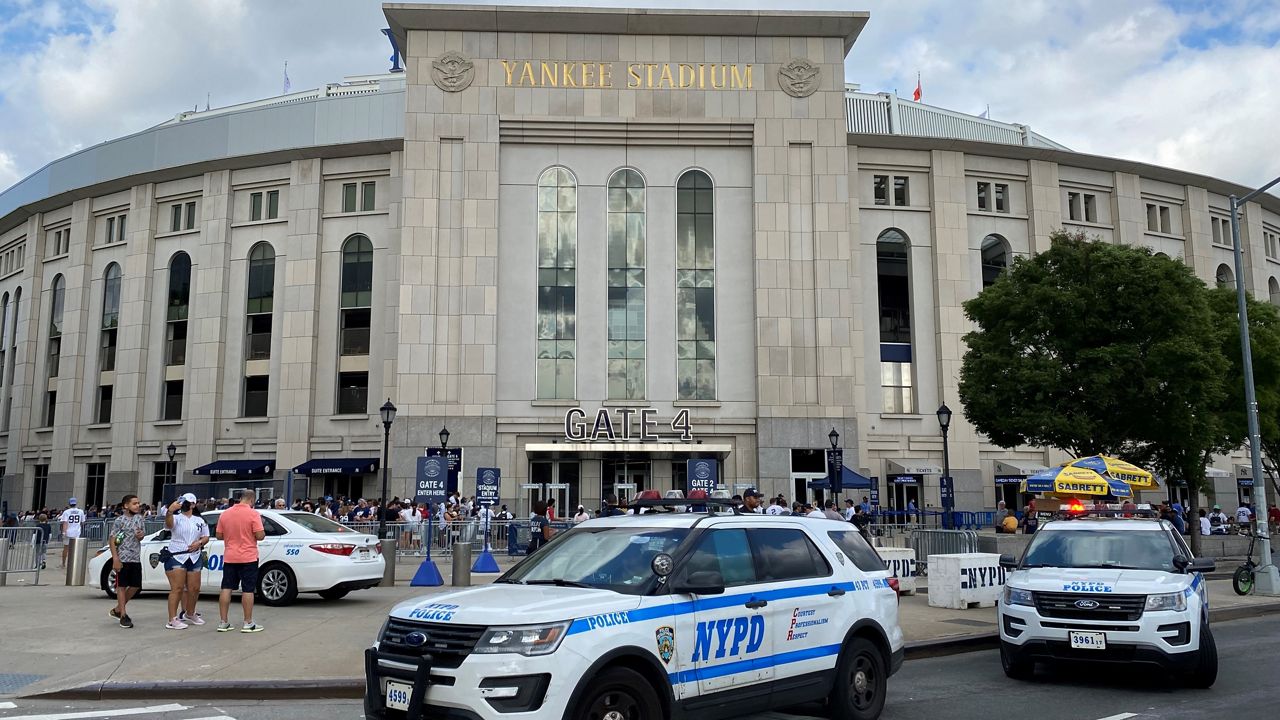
[{"xmin": 0, "ymin": 0, "xmax": 1280, "ymax": 188}]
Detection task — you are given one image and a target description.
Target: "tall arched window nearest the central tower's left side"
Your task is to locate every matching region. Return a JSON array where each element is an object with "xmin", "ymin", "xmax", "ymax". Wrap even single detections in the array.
[{"xmin": 338, "ymin": 234, "xmax": 374, "ymax": 415}]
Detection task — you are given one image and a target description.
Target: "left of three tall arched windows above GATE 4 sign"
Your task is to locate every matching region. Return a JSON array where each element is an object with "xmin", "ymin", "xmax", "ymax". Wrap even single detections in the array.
[{"xmin": 536, "ymin": 168, "xmax": 577, "ymax": 398}]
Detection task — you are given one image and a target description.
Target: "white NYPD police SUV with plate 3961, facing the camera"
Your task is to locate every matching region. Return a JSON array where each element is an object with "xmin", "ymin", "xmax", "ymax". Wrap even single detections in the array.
[{"xmin": 998, "ymin": 504, "xmax": 1217, "ymax": 688}]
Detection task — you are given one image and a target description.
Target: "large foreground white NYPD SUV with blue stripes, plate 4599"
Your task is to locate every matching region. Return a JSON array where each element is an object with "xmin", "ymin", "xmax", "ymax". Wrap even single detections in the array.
[{"xmin": 365, "ymin": 502, "xmax": 902, "ymax": 720}]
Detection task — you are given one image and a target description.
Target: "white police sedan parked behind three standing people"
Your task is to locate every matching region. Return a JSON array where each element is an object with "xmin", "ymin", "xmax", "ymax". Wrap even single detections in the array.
[{"xmin": 88, "ymin": 510, "xmax": 387, "ymax": 605}]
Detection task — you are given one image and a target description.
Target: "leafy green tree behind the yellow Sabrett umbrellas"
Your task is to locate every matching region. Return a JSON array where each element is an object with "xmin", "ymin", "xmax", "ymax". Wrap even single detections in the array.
[{"xmin": 960, "ymin": 231, "xmax": 1228, "ymax": 542}]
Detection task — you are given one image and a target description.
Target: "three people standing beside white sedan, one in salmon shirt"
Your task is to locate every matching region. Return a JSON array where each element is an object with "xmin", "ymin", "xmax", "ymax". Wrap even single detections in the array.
[{"xmin": 107, "ymin": 489, "xmax": 266, "ymax": 633}]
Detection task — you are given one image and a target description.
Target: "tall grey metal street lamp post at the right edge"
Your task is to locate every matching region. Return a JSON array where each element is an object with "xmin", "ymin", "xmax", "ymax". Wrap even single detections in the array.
[{"xmin": 1229, "ymin": 178, "xmax": 1280, "ymax": 594}]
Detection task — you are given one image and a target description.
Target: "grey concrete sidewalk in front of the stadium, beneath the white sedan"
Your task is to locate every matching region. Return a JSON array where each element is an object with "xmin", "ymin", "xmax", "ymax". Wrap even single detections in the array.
[{"xmin": 0, "ymin": 548, "xmax": 1280, "ymax": 698}]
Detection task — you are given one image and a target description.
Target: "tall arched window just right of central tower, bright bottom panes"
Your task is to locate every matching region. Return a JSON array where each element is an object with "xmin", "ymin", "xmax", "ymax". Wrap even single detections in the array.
[{"xmin": 876, "ymin": 228, "xmax": 915, "ymax": 413}]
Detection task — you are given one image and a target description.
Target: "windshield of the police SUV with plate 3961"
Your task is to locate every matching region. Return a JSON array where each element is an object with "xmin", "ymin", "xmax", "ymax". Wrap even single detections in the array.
[{"xmin": 1023, "ymin": 528, "xmax": 1175, "ymax": 573}]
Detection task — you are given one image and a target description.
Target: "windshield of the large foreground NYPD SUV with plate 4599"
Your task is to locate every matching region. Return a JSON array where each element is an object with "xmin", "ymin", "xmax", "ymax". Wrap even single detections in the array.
[{"xmin": 498, "ymin": 520, "xmax": 689, "ymax": 594}]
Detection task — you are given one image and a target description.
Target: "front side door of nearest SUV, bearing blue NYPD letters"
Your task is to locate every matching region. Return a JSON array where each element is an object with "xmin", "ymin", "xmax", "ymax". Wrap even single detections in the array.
[{"xmin": 675, "ymin": 527, "xmax": 773, "ymax": 697}]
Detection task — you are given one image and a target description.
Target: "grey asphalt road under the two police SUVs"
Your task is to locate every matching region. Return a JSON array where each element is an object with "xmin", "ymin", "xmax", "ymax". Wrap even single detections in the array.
[{"xmin": 0, "ymin": 616, "xmax": 1280, "ymax": 720}]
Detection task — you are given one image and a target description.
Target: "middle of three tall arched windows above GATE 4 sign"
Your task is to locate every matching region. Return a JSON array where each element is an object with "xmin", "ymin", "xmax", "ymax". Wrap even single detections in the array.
[{"xmin": 608, "ymin": 168, "xmax": 645, "ymax": 400}]
